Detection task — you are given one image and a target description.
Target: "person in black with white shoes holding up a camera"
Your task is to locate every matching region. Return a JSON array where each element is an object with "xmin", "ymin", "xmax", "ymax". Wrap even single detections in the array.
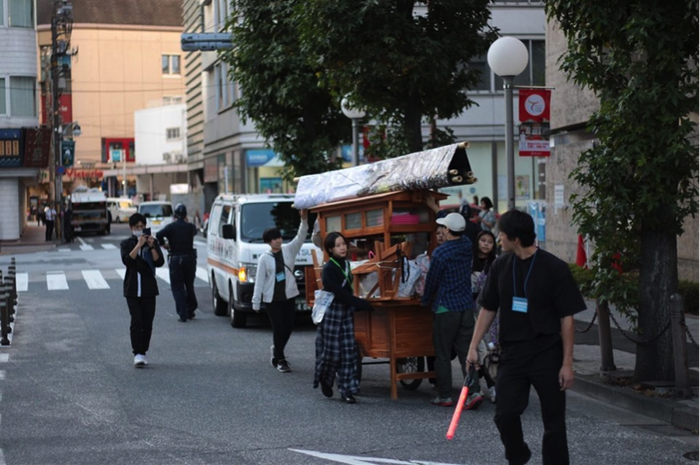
[{"xmin": 120, "ymin": 213, "xmax": 165, "ymax": 368}]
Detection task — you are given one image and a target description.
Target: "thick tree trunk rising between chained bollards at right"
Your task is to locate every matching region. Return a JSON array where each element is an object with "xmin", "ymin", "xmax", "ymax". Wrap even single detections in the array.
[{"xmin": 634, "ymin": 227, "xmax": 678, "ymax": 381}]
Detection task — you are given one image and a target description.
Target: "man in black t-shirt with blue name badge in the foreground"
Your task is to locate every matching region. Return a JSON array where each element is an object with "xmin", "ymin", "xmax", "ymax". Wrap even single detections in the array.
[{"xmin": 467, "ymin": 210, "xmax": 586, "ymax": 465}]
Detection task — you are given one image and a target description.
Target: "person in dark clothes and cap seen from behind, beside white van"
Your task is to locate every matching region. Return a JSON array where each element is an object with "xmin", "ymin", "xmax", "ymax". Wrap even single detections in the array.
[{"xmin": 156, "ymin": 203, "xmax": 197, "ymax": 323}]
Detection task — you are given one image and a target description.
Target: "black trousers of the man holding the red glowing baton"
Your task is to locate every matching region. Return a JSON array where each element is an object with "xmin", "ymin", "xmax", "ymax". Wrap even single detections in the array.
[{"xmin": 494, "ymin": 342, "xmax": 569, "ymax": 465}]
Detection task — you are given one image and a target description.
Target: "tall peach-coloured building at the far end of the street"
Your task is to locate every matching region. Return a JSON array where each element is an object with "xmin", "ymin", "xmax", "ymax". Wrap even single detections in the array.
[{"xmin": 35, "ymin": 0, "xmax": 185, "ymax": 203}]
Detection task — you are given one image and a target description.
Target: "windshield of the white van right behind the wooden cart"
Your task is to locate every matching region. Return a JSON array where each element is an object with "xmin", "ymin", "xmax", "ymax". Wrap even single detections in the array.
[{"xmin": 240, "ymin": 202, "xmax": 316, "ymax": 242}]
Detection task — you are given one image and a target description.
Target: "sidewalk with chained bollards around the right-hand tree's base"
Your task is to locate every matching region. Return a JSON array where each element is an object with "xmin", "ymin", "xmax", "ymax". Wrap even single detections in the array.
[{"xmin": 573, "ymin": 302, "xmax": 700, "ymax": 431}]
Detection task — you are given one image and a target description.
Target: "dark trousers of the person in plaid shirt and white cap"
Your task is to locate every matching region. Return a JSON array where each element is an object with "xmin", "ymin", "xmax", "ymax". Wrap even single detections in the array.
[{"xmin": 433, "ymin": 310, "xmax": 480, "ymax": 398}]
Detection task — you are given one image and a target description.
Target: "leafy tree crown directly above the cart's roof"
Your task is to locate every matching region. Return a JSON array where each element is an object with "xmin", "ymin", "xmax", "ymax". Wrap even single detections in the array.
[{"xmin": 295, "ymin": 0, "xmax": 496, "ymax": 153}]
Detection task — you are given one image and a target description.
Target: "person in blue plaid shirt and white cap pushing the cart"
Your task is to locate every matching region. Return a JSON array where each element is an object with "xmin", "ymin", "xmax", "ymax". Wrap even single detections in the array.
[{"xmin": 421, "ymin": 213, "xmax": 483, "ymax": 410}]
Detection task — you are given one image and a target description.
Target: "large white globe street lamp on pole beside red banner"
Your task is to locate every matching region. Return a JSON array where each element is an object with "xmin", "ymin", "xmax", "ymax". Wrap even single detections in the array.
[{"xmin": 487, "ymin": 37, "xmax": 529, "ymax": 210}]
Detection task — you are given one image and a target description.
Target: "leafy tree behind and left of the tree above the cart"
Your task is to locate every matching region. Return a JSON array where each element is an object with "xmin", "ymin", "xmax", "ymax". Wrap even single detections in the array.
[{"xmin": 221, "ymin": 0, "xmax": 351, "ymax": 180}]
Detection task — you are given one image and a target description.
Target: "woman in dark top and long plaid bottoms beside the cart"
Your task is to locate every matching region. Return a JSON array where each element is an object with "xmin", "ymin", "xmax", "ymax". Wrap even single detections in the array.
[{"xmin": 314, "ymin": 232, "xmax": 373, "ymax": 404}]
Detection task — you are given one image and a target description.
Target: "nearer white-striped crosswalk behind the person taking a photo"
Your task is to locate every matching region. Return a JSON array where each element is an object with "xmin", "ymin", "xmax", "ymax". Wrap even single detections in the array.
[{"xmin": 17, "ymin": 266, "xmax": 209, "ymax": 292}]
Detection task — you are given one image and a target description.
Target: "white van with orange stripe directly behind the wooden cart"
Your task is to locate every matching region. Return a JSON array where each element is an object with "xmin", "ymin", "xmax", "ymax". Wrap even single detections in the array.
[{"xmin": 207, "ymin": 194, "xmax": 319, "ymax": 328}]
